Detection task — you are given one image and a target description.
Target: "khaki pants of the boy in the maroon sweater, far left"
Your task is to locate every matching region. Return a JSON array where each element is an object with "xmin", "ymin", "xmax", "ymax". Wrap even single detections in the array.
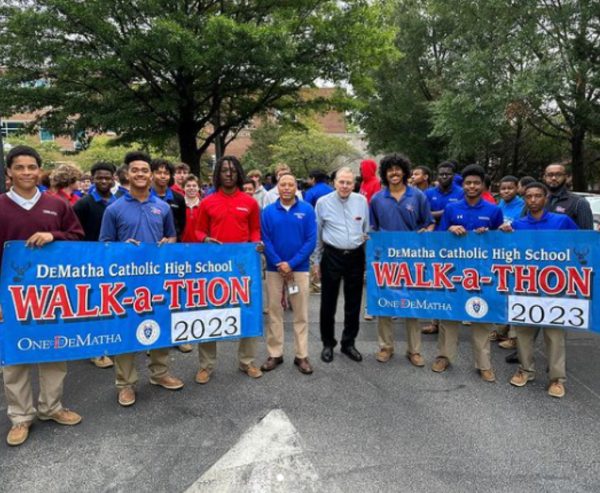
[{"xmin": 3, "ymin": 362, "xmax": 67, "ymax": 425}]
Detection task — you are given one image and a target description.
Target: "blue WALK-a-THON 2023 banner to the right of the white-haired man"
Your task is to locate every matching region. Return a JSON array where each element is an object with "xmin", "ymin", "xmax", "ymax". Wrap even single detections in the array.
[{"xmin": 367, "ymin": 231, "xmax": 600, "ymax": 332}]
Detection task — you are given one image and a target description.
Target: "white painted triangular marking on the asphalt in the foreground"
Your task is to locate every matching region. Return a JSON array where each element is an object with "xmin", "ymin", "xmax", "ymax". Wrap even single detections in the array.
[{"xmin": 186, "ymin": 409, "xmax": 326, "ymax": 493}]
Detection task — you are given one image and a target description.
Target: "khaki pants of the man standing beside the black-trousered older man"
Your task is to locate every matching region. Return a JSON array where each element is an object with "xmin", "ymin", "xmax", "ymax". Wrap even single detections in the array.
[{"xmin": 267, "ymin": 272, "xmax": 310, "ymax": 358}]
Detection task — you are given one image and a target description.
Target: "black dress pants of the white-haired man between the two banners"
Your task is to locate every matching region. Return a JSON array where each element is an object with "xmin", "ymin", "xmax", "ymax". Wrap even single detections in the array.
[{"xmin": 319, "ymin": 245, "xmax": 365, "ymax": 347}]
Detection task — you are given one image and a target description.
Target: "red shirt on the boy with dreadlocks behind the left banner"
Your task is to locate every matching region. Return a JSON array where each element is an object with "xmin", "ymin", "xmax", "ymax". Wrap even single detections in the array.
[{"xmin": 194, "ymin": 190, "xmax": 260, "ymax": 243}]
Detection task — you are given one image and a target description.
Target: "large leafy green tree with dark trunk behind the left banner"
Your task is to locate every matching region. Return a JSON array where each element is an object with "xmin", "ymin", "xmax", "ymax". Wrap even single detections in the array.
[{"xmin": 0, "ymin": 0, "xmax": 388, "ymax": 177}]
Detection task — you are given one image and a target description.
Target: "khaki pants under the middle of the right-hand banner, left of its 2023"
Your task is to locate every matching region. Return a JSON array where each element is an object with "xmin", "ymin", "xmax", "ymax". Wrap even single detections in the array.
[{"xmin": 438, "ymin": 320, "xmax": 492, "ymax": 370}]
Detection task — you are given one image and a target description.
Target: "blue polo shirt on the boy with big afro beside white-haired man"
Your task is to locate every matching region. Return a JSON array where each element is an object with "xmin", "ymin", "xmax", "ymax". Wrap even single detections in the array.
[{"xmin": 369, "ymin": 187, "xmax": 435, "ymax": 231}]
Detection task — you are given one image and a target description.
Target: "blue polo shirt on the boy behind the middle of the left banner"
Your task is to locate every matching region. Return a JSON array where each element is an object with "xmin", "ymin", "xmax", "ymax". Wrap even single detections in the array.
[{"xmin": 99, "ymin": 192, "xmax": 176, "ymax": 243}]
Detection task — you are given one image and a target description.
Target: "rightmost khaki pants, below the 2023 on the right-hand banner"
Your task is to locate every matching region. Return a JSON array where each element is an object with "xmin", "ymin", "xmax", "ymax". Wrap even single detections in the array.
[{"xmin": 515, "ymin": 326, "xmax": 567, "ymax": 382}]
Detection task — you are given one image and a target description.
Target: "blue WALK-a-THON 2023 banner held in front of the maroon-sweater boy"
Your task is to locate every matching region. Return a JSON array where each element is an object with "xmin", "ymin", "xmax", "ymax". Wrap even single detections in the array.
[{"xmin": 0, "ymin": 241, "xmax": 263, "ymax": 365}]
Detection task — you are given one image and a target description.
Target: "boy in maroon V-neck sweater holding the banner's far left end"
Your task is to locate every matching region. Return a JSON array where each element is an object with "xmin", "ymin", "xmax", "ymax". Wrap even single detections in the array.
[{"xmin": 0, "ymin": 146, "xmax": 83, "ymax": 446}]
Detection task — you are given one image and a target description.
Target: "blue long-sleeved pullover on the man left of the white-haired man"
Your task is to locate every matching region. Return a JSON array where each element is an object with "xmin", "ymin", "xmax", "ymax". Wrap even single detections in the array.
[{"xmin": 260, "ymin": 199, "xmax": 317, "ymax": 272}]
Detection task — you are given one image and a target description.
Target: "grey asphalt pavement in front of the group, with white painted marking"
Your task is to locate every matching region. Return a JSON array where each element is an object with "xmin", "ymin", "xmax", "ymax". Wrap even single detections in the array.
[{"xmin": 0, "ymin": 295, "xmax": 600, "ymax": 493}]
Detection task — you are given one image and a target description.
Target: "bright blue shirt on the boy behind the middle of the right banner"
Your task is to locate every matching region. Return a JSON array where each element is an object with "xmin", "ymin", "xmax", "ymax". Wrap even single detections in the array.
[{"xmin": 439, "ymin": 198, "xmax": 504, "ymax": 231}]
